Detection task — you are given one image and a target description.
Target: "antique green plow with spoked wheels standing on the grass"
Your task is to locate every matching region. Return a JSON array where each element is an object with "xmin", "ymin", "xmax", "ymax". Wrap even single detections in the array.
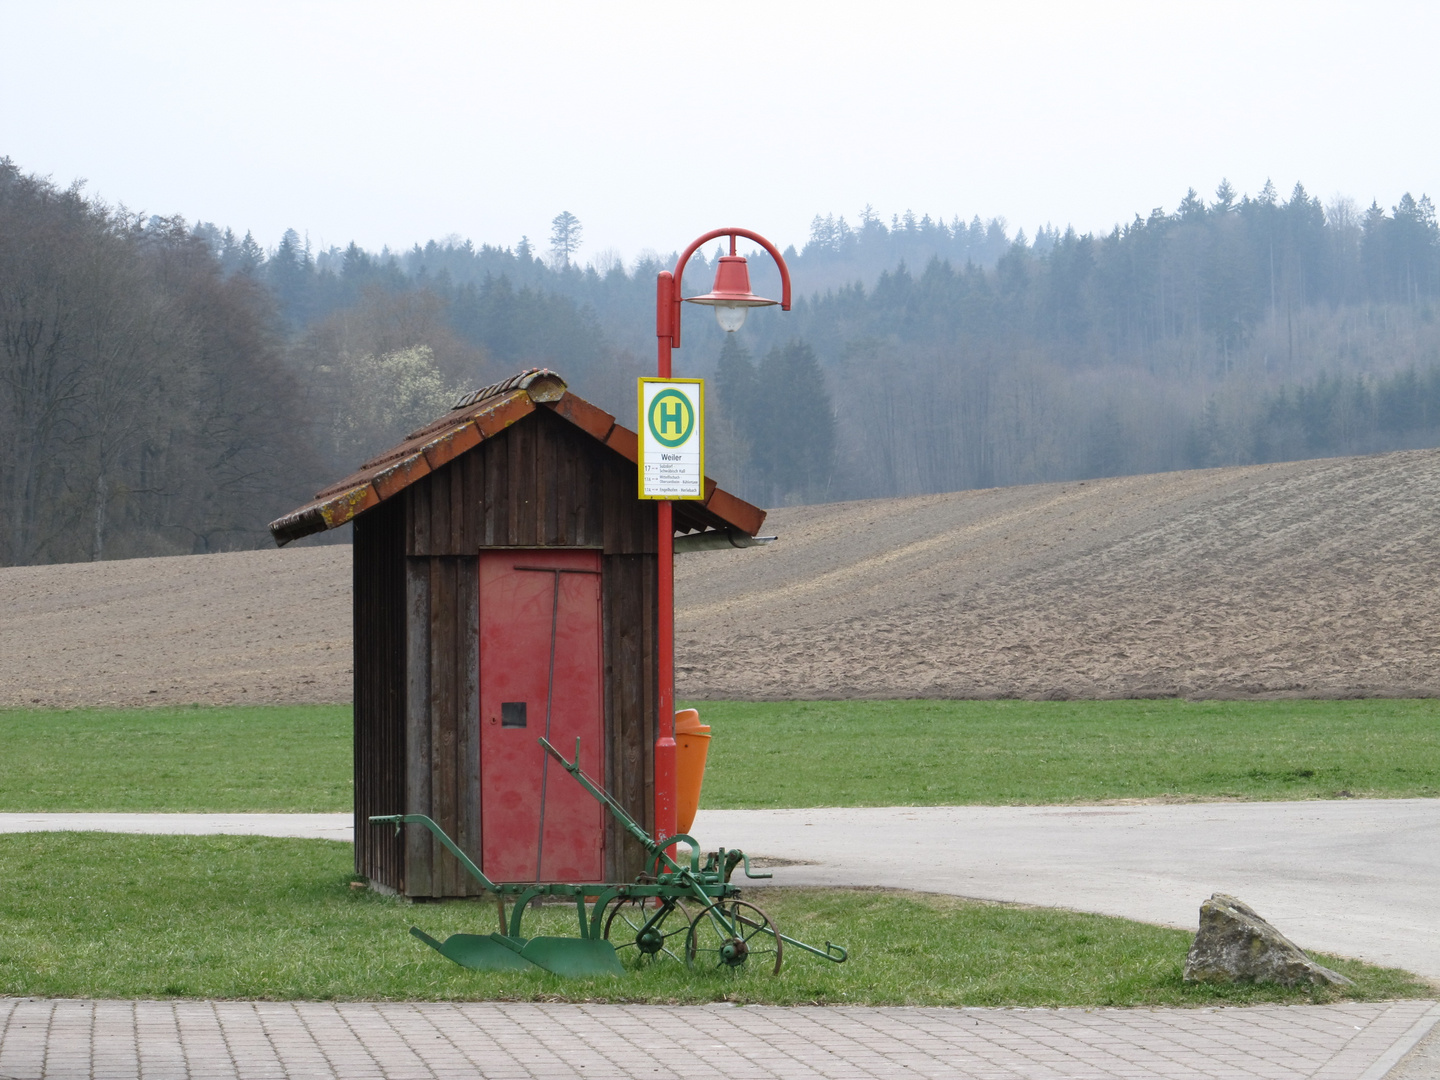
[{"xmin": 370, "ymin": 739, "xmax": 847, "ymax": 976}]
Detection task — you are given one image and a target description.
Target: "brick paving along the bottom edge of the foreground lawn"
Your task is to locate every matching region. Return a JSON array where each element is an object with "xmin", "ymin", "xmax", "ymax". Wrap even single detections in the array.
[{"xmin": 0, "ymin": 998, "xmax": 1440, "ymax": 1080}]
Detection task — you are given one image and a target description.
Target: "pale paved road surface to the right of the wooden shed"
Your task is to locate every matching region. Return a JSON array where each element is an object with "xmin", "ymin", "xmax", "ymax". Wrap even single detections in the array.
[{"xmin": 693, "ymin": 799, "xmax": 1440, "ymax": 979}]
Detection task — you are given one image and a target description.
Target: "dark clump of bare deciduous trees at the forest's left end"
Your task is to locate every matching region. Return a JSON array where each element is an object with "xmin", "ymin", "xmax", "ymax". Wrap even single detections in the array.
[{"xmin": 0, "ymin": 160, "xmax": 318, "ymax": 563}]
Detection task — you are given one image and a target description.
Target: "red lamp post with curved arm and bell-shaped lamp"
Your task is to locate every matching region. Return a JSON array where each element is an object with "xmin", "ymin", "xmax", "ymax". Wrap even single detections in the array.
[{"xmin": 655, "ymin": 229, "xmax": 791, "ymax": 840}]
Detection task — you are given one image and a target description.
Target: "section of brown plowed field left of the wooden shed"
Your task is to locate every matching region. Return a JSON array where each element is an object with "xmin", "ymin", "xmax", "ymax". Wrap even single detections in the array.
[{"xmin": 0, "ymin": 546, "xmax": 350, "ymax": 707}]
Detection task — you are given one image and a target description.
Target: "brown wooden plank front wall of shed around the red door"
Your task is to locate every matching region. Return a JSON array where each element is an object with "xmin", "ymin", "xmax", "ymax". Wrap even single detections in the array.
[{"xmin": 395, "ymin": 409, "xmax": 657, "ymax": 897}]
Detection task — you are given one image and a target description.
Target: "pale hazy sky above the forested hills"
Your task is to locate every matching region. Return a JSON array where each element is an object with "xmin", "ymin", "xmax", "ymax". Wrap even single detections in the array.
[{"xmin": 0, "ymin": 0, "xmax": 1440, "ymax": 261}]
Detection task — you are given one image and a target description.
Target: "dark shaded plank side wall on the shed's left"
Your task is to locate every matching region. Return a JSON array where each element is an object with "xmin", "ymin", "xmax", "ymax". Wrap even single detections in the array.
[{"xmin": 351, "ymin": 500, "xmax": 405, "ymax": 891}]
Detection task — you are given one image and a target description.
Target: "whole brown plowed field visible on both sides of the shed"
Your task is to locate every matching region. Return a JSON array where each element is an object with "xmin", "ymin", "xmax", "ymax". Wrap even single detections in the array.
[{"xmin": 0, "ymin": 451, "xmax": 1440, "ymax": 706}]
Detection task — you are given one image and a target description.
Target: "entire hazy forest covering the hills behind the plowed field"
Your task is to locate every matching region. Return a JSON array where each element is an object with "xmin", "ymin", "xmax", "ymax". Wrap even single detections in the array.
[{"xmin": 0, "ymin": 158, "xmax": 1440, "ymax": 564}]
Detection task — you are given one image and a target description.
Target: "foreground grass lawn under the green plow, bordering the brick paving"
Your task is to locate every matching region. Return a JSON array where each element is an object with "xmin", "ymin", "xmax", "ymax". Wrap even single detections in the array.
[{"xmin": 0, "ymin": 832, "xmax": 1434, "ymax": 1005}]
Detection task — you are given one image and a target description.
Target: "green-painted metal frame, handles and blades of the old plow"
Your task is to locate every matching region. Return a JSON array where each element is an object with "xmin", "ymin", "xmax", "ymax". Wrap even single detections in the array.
[{"xmin": 370, "ymin": 739, "xmax": 847, "ymax": 975}]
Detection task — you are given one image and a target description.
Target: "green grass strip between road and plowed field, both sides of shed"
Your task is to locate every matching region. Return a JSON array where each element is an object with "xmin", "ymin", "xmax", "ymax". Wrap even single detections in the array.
[{"xmin": 0, "ymin": 700, "xmax": 1440, "ymax": 812}]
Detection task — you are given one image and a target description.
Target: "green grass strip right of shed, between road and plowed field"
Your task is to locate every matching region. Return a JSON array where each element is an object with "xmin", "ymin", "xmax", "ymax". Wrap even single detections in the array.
[{"xmin": 693, "ymin": 698, "xmax": 1440, "ymax": 809}]
